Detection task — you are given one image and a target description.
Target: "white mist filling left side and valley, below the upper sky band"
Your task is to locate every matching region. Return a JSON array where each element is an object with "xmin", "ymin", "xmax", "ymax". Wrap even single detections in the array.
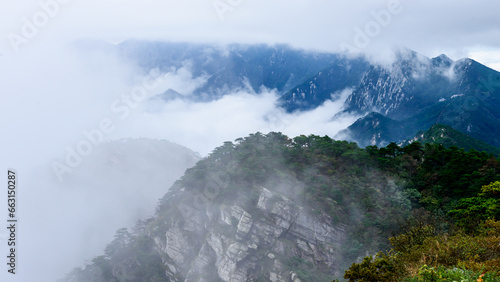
[{"xmin": 0, "ymin": 40, "xmax": 364, "ymax": 281}]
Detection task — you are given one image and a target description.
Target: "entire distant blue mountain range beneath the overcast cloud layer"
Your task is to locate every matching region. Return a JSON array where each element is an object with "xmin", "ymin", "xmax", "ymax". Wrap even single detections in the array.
[{"xmin": 106, "ymin": 41, "xmax": 500, "ymax": 150}]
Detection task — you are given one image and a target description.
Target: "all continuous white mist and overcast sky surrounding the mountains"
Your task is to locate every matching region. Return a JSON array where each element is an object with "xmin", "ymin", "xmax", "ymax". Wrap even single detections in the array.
[{"xmin": 0, "ymin": 0, "xmax": 500, "ymax": 281}]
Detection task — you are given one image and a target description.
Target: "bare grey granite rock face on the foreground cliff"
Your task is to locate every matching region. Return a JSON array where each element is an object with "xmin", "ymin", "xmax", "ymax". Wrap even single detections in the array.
[{"xmin": 154, "ymin": 187, "xmax": 345, "ymax": 282}]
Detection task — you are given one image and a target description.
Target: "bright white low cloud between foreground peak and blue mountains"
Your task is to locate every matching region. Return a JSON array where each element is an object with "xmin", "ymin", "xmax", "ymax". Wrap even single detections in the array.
[{"xmin": 111, "ymin": 83, "xmax": 357, "ymax": 155}]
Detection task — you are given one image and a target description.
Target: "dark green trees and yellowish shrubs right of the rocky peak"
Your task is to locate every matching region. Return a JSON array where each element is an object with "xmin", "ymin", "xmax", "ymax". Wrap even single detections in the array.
[{"xmin": 344, "ymin": 143, "xmax": 500, "ymax": 281}]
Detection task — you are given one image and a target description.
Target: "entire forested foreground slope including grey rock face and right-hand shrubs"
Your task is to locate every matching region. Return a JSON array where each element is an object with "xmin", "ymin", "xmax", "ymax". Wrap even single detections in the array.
[{"xmin": 62, "ymin": 132, "xmax": 500, "ymax": 281}]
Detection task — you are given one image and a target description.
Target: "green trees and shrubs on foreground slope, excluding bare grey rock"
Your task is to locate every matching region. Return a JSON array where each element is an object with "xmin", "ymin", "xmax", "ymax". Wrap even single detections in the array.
[{"xmin": 62, "ymin": 132, "xmax": 500, "ymax": 281}]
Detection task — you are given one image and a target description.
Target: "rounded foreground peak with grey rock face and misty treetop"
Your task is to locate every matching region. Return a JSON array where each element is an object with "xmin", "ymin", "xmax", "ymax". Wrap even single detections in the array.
[{"xmin": 65, "ymin": 133, "xmax": 410, "ymax": 282}]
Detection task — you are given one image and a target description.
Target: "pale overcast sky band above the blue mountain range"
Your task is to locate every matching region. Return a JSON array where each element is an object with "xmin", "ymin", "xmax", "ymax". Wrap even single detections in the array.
[{"xmin": 0, "ymin": 0, "xmax": 500, "ymax": 69}]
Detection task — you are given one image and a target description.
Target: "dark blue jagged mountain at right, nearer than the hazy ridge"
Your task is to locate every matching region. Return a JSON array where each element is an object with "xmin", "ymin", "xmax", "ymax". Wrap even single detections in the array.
[{"xmin": 339, "ymin": 50, "xmax": 500, "ymax": 147}]
